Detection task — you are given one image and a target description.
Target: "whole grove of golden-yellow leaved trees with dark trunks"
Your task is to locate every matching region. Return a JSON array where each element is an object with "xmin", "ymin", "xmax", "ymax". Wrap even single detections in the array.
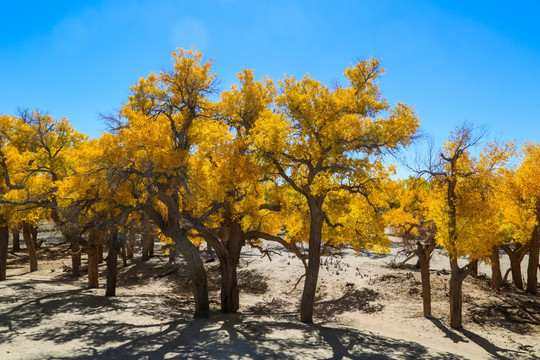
[{"xmin": 0, "ymin": 49, "xmax": 540, "ymax": 328}]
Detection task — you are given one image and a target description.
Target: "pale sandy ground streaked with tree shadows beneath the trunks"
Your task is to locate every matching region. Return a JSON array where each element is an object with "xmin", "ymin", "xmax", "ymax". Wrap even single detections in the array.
[{"xmin": 0, "ymin": 236, "xmax": 540, "ymax": 359}]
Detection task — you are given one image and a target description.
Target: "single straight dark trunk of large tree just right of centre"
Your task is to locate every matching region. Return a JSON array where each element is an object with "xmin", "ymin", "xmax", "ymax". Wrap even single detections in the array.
[{"xmin": 300, "ymin": 199, "xmax": 324, "ymax": 323}]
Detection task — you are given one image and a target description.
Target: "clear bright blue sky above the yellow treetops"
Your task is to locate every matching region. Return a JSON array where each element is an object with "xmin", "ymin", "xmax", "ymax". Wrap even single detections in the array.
[{"xmin": 0, "ymin": 0, "xmax": 540, "ymax": 159}]
